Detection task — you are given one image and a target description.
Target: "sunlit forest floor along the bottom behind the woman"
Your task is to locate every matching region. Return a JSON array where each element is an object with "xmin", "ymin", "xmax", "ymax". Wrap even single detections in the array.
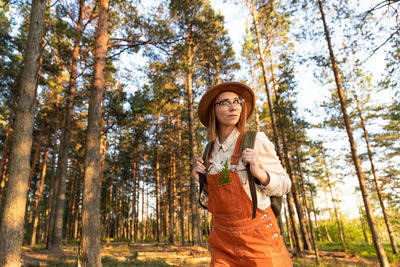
[{"xmin": 22, "ymin": 242, "xmax": 400, "ymax": 267}]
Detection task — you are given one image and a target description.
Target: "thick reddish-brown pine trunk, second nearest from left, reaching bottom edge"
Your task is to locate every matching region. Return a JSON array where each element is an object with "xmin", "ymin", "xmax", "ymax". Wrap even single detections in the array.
[{"xmin": 79, "ymin": 0, "xmax": 109, "ymax": 267}]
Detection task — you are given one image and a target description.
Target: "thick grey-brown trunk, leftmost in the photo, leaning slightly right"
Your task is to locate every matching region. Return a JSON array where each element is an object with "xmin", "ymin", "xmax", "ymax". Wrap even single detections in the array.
[{"xmin": 0, "ymin": 0, "xmax": 47, "ymax": 266}]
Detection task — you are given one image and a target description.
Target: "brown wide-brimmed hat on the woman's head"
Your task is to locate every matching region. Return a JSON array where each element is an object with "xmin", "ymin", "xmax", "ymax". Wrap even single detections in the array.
[{"xmin": 198, "ymin": 82, "xmax": 256, "ymax": 127}]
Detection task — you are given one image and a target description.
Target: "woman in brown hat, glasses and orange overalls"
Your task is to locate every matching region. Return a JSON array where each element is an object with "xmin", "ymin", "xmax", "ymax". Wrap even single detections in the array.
[{"xmin": 193, "ymin": 82, "xmax": 292, "ymax": 267}]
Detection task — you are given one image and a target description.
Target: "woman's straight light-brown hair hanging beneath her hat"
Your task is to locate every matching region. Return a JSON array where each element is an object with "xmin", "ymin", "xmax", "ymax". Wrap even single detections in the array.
[{"xmin": 207, "ymin": 97, "xmax": 247, "ymax": 142}]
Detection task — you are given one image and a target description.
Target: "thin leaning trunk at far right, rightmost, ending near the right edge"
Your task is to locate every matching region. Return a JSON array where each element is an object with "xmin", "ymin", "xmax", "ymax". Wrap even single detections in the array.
[{"xmin": 354, "ymin": 94, "xmax": 399, "ymax": 255}]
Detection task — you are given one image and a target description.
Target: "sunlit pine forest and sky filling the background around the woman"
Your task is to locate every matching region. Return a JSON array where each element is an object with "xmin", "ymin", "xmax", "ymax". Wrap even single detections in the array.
[{"xmin": 0, "ymin": 0, "xmax": 400, "ymax": 266}]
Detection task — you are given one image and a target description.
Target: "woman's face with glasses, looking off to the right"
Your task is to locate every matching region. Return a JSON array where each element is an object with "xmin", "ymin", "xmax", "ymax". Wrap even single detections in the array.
[{"xmin": 214, "ymin": 92, "xmax": 242, "ymax": 130}]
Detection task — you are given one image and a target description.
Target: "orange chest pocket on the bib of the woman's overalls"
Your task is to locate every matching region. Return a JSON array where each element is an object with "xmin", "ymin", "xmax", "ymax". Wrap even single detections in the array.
[{"xmin": 208, "ymin": 181, "xmax": 242, "ymax": 217}]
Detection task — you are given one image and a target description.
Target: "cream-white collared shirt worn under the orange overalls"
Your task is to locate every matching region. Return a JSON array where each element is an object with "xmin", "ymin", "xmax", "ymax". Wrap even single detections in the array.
[{"xmin": 207, "ymin": 128, "xmax": 292, "ymax": 210}]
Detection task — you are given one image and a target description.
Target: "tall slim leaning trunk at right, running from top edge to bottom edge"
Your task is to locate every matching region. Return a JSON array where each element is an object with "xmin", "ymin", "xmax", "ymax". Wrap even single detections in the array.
[{"xmin": 318, "ymin": 0, "xmax": 390, "ymax": 267}]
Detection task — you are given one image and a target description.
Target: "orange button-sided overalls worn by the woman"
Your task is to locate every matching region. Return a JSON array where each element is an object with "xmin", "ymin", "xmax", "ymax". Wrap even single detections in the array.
[{"xmin": 207, "ymin": 134, "xmax": 292, "ymax": 267}]
